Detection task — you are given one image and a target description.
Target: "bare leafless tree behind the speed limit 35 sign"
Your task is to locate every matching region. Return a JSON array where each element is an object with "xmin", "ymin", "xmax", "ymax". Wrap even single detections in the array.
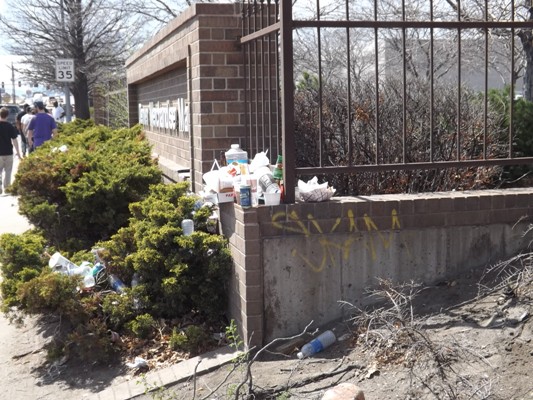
[{"xmin": 0, "ymin": 0, "xmax": 146, "ymax": 119}]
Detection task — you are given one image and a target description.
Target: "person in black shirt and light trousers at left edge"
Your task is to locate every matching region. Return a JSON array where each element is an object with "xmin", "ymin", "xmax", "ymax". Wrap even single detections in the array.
[{"xmin": 0, "ymin": 107, "xmax": 21, "ymax": 194}]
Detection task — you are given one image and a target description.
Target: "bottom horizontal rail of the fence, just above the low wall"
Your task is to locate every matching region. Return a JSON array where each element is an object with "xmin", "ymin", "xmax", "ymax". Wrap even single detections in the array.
[{"xmin": 295, "ymin": 157, "xmax": 533, "ymax": 175}]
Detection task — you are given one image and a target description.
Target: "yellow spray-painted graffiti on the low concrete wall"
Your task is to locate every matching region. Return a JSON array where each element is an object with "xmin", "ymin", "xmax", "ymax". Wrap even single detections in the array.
[{"xmin": 272, "ymin": 210, "xmax": 408, "ymax": 272}]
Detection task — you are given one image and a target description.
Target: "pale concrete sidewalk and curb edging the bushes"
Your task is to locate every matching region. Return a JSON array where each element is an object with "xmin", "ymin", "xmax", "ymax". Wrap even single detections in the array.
[{"xmin": 0, "ymin": 156, "xmax": 238, "ymax": 400}]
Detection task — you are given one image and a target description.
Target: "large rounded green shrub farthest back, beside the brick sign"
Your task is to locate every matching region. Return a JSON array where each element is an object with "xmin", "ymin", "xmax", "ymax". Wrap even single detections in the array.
[{"xmin": 12, "ymin": 122, "xmax": 161, "ymax": 252}]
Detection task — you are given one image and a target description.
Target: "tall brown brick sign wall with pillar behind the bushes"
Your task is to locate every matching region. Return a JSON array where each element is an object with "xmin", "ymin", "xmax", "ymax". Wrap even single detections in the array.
[{"xmin": 126, "ymin": 4, "xmax": 244, "ymax": 191}]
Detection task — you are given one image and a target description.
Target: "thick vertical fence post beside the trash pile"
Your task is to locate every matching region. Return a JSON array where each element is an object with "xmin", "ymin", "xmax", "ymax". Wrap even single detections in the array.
[{"xmin": 280, "ymin": 1, "xmax": 296, "ymax": 203}]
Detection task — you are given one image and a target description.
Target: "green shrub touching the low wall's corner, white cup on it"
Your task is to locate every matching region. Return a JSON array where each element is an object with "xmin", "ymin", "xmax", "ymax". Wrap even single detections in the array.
[{"xmin": 100, "ymin": 183, "xmax": 232, "ymax": 320}]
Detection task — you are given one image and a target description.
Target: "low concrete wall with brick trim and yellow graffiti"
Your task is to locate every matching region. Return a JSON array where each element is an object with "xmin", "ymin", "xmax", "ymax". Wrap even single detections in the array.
[{"xmin": 220, "ymin": 189, "xmax": 533, "ymax": 345}]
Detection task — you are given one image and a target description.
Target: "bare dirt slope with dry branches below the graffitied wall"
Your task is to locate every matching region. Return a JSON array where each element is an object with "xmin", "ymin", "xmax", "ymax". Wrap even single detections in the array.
[{"xmin": 140, "ymin": 269, "xmax": 533, "ymax": 400}]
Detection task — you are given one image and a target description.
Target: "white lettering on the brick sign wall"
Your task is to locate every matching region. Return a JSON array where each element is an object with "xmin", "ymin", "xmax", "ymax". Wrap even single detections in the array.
[{"xmin": 139, "ymin": 99, "xmax": 189, "ymax": 132}]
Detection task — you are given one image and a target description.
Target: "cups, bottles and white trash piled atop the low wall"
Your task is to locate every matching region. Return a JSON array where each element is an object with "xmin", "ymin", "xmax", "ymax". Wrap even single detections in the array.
[{"xmin": 202, "ymin": 144, "xmax": 335, "ymax": 208}]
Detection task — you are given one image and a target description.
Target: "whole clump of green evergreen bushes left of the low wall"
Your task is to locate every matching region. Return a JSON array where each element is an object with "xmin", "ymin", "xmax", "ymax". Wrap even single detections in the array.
[{"xmin": 0, "ymin": 121, "xmax": 232, "ymax": 362}]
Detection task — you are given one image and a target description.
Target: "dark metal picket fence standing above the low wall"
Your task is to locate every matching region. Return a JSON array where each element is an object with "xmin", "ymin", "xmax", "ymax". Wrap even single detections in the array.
[{"xmin": 241, "ymin": 0, "xmax": 533, "ymax": 203}]
